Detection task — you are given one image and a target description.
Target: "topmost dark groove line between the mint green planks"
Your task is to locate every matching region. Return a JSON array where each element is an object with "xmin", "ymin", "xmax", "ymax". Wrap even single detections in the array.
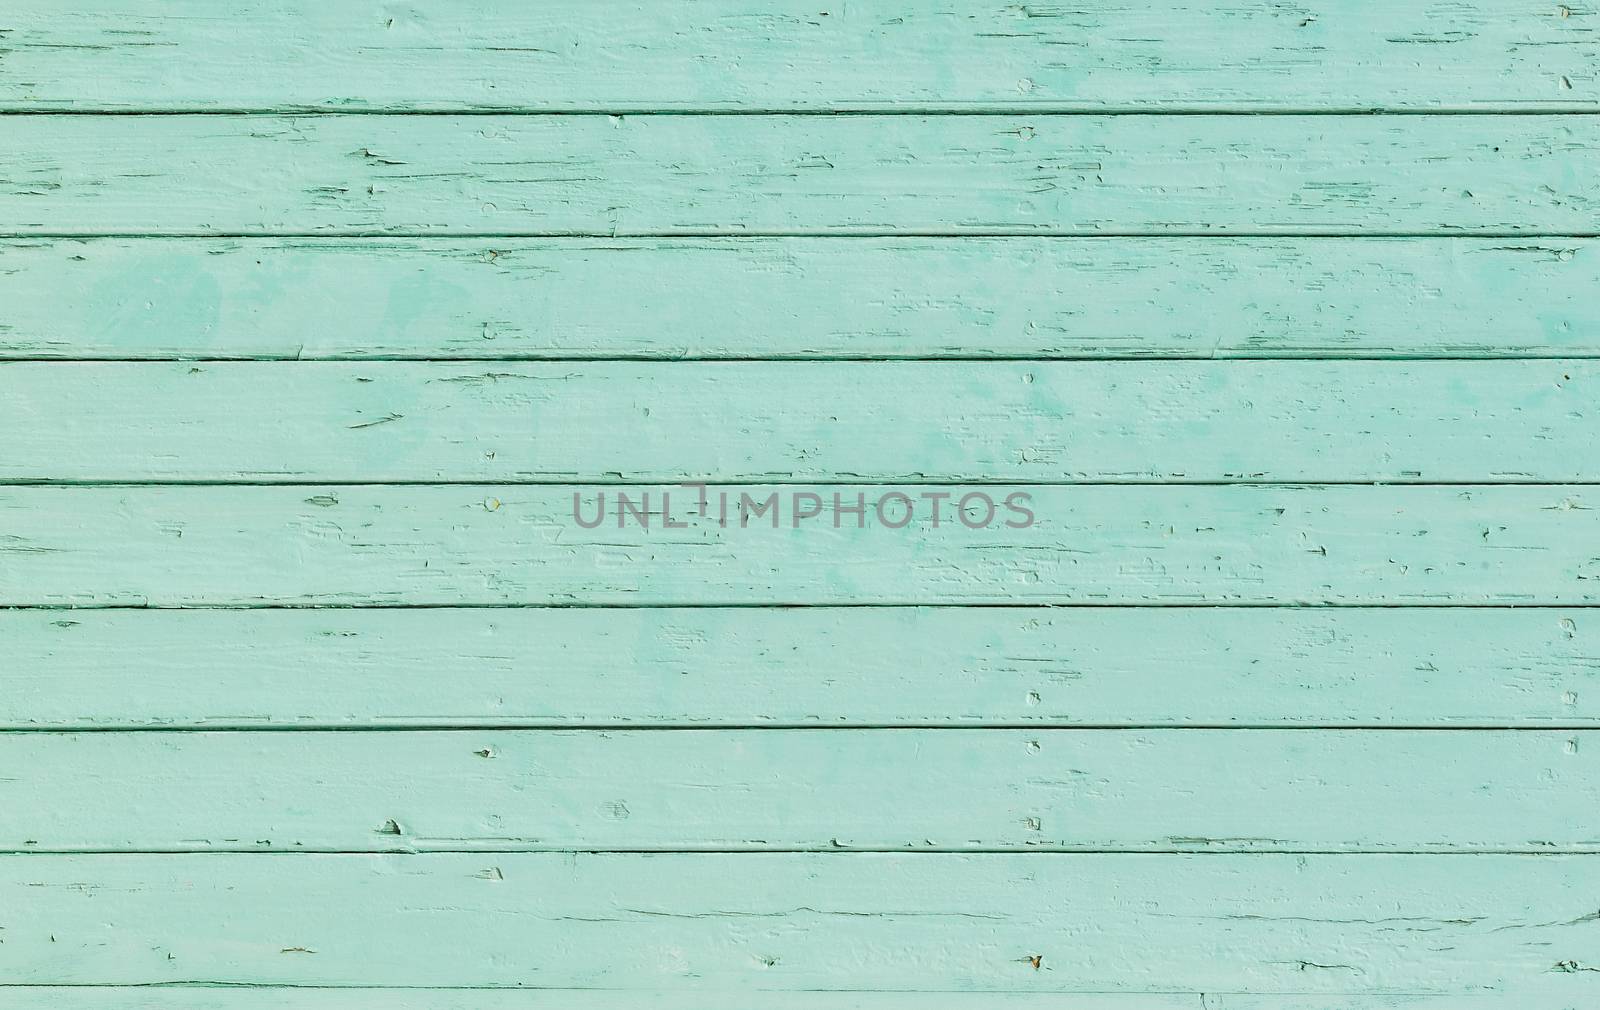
[{"xmin": 0, "ymin": 101, "xmax": 1600, "ymax": 118}]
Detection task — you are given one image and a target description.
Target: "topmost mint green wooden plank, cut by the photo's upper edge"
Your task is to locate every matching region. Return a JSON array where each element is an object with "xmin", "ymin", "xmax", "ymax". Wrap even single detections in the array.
[{"xmin": 0, "ymin": 0, "xmax": 1600, "ymax": 110}]
